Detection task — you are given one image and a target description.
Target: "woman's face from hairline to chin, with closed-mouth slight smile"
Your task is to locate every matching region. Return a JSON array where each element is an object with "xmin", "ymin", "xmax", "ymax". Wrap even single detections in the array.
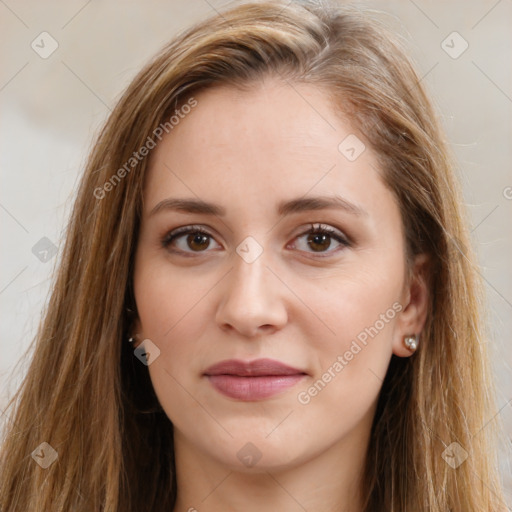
[{"xmin": 134, "ymin": 80, "xmax": 424, "ymax": 469}]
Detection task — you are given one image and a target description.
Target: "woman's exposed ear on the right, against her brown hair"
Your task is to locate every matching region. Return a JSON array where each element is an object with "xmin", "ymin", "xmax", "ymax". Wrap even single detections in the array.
[{"xmin": 393, "ymin": 254, "xmax": 430, "ymax": 357}]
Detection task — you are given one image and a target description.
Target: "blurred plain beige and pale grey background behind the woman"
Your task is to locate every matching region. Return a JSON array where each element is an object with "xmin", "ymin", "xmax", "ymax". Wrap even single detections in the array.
[{"xmin": 0, "ymin": 0, "xmax": 512, "ymax": 504}]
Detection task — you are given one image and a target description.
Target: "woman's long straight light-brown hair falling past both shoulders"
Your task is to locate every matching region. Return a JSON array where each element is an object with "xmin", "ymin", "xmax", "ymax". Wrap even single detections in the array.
[{"xmin": 0, "ymin": 1, "xmax": 504, "ymax": 512}]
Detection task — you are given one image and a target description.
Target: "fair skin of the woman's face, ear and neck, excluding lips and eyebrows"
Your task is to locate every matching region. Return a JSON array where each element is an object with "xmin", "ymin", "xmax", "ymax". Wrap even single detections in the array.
[{"xmin": 134, "ymin": 79, "xmax": 428, "ymax": 512}]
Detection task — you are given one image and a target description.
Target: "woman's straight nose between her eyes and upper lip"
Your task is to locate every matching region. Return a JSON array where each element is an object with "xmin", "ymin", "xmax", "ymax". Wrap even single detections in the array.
[{"xmin": 215, "ymin": 246, "xmax": 288, "ymax": 337}]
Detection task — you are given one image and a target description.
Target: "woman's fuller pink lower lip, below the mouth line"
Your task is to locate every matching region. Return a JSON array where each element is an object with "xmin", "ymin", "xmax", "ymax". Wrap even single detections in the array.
[{"xmin": 207, "ymin": 374, "xmax": 306, "ymax": 401}]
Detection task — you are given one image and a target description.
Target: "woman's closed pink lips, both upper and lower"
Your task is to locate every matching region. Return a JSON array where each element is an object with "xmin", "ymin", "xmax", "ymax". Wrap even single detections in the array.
[{"xmin": 204, "ymin": 359, "xmax": 306, "ymax": 401}]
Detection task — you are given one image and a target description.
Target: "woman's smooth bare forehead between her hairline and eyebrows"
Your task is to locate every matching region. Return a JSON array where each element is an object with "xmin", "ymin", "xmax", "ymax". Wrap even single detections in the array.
[{"xmin": 145, "ymin": 80, "xmax": 386, "ymax": 216}]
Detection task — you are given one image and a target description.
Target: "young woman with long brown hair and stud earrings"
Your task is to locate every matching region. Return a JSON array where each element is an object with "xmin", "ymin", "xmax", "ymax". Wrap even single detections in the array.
[{"xmin": 0, "ymin": 2, "xmax": 505, "ymax": 512}]
